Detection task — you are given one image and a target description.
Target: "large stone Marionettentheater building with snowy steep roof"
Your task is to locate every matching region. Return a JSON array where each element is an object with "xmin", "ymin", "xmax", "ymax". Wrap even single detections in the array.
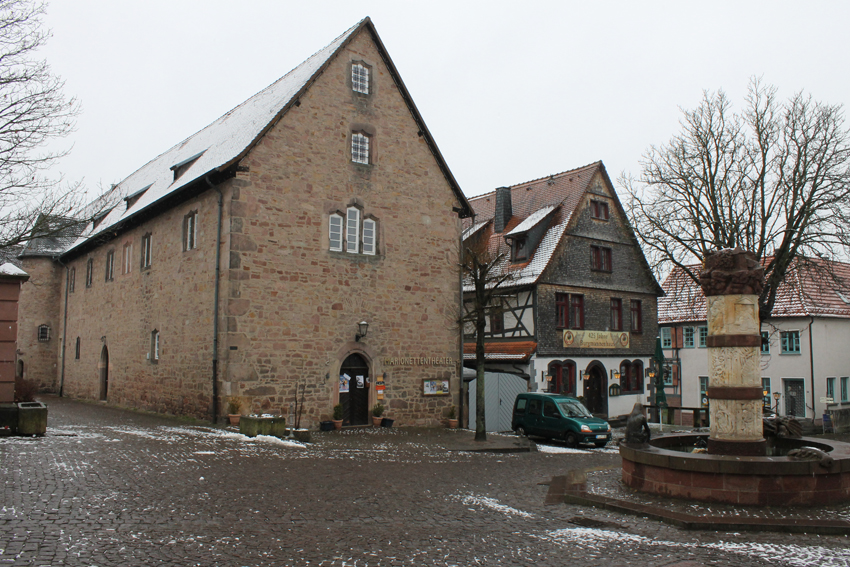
[{"xmin": 16, "ymin": 18, "xmax": 471, "ymax": 425}]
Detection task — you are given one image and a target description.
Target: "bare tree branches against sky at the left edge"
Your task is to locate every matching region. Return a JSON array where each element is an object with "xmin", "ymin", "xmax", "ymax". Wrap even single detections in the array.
[{"xmin": 0, "ymin": 0, "xmax": 83, "ymax": 252}]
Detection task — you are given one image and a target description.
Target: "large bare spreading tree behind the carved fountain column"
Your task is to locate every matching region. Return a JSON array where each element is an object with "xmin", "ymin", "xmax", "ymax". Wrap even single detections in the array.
[{"xmin": 620, "ymin": 78, "xmax": 850, "ymax": 320}]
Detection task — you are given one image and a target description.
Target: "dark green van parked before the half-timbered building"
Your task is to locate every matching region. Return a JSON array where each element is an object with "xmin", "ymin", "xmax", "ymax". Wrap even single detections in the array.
[{"xmin": 511, "ymin": 393, "xmax": 611, "ymax": 447}]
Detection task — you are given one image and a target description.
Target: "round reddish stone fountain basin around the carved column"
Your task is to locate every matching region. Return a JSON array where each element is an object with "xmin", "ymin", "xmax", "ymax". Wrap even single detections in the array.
[{"xmin": 620, "ymin": 434, "xmax": 850, "ymax": 506}]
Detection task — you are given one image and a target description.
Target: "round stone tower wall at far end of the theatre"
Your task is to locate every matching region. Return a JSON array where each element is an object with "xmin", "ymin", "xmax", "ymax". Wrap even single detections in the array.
[{"xmin": 18, "ymin": 256, "xmax": 65, "ymax": 392}]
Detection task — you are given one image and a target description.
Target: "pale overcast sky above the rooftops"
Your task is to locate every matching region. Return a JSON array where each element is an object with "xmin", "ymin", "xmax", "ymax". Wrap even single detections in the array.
[{"xmin": 42, "ymin": 0, "xmax": 850, "ymax": 200}]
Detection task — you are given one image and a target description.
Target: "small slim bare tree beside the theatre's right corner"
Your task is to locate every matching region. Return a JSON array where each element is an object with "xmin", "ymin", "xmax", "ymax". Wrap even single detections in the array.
[{"xmin": 461, "ymin": 239, "xmax": 514, "ymax": 441}]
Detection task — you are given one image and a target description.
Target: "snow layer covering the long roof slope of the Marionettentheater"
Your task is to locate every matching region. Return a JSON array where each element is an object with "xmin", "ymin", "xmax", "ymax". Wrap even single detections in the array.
[{"xmin": 63, "ymin": 20, "xmax": 365, "ymax": 254}]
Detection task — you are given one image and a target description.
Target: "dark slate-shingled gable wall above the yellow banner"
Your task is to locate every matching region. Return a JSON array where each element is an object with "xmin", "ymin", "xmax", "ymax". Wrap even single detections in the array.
[{"xmin": 537, "ymin": 174, "xmax": 658, "ymax": 358}]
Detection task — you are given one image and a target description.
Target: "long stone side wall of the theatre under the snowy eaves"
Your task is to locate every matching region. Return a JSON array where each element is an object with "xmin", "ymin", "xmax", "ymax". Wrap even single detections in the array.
[{"xmin": 57, "ymin": 187, "xmax": 230, "ymax": 418}]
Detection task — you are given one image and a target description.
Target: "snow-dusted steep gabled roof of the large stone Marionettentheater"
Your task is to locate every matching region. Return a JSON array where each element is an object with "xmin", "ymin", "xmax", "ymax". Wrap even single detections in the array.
[{"xmin": 63, "ymin": 18, "xmax": 471, "ymax": 258}]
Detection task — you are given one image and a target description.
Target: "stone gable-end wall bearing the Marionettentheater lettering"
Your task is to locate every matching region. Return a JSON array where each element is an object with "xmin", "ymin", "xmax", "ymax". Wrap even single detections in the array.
[{"xmin": 224, "ymin": 27, "xmax": 460, "ymax": 425}]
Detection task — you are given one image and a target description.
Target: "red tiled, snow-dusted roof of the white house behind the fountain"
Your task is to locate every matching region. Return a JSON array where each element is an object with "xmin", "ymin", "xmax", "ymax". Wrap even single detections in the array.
[{"xmin": 658, "ymin": 258, "xmax": 850, "ymax": 325}]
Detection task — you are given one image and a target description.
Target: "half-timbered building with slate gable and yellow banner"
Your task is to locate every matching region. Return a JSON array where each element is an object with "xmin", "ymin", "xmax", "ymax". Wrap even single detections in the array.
[{"xmin": 464, "ymin": 162, "xmax": 662, "ymax": 419}]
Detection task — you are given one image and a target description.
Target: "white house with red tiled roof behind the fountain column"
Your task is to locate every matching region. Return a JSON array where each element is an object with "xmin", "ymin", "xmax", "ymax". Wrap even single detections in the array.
[{"xmin": 658, "ymin": 260, "xmax": 850, "ymax": 423}]
